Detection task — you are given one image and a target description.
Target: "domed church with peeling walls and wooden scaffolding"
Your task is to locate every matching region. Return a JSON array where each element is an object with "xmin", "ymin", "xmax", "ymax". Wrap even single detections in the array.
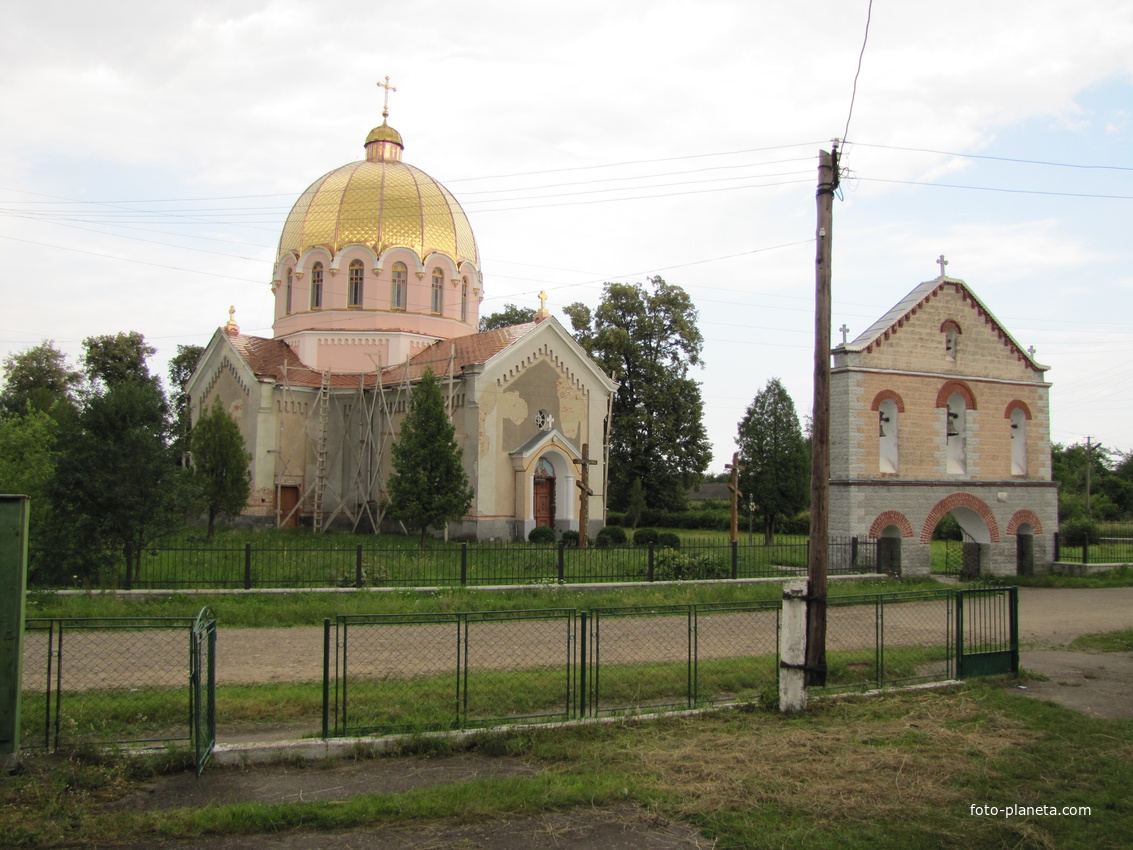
[{"xmin": 187, "ymin": 94, "xmax": 616, "ymax": 539}]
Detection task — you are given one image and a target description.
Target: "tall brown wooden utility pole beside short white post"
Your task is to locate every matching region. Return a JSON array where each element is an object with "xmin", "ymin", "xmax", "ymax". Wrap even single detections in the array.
[{"xmin": 806, "ymin": 145, "xmax": 838, "ymax": 687}]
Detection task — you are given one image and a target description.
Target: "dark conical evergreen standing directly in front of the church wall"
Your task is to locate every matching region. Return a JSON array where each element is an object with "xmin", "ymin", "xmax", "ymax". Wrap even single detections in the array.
[{"xmin": 389, "ymin": 369, "xmax": 472, "ymax": 547}]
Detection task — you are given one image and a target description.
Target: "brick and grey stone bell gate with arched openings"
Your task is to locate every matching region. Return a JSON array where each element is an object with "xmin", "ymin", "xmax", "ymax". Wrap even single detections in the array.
[{"xmin": 829, "ymin": 256, "xmax": 1058, "ymax": 576}]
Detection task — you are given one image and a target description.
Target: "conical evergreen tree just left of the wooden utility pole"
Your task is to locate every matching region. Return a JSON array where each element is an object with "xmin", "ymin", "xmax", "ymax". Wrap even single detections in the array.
[{"xmin": 735, "ymin": 377, "xmax": 810, "ymax": 544}]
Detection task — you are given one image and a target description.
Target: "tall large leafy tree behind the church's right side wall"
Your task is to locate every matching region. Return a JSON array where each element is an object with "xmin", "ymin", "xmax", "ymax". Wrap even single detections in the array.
[{"xmin": 565, "ymin": 278, "xmax": 712, "ymax": 510}]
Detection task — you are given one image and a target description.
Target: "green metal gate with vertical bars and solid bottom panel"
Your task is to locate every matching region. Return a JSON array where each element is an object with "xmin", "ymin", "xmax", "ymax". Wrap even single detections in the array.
[{"xmin": 956, "ymin": 587, "xmax": 1019, "ymax": 679}]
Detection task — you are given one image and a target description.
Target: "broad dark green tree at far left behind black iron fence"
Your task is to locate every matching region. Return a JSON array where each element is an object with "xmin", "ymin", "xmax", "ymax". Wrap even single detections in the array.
[{"xmin": 49, "ymin": 376, "xmax": 186, "ymax": 586}]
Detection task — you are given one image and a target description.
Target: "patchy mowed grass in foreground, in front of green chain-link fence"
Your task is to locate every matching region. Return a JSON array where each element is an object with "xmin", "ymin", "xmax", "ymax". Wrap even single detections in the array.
[{"xmin": 0, "ymin": 681, "xmax": 1133, "ymax": 850}]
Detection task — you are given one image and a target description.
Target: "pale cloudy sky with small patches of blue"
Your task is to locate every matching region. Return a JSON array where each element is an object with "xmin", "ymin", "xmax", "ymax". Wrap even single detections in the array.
[{"xmin": 0, "ymin": 0, "xmax": 1133, "ymax": 471}]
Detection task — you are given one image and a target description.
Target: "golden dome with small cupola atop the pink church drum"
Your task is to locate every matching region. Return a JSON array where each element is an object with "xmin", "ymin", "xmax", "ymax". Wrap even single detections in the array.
[{"xmin": 278, "ymin": 121, "xmax": 480, "ymax": 269}]
